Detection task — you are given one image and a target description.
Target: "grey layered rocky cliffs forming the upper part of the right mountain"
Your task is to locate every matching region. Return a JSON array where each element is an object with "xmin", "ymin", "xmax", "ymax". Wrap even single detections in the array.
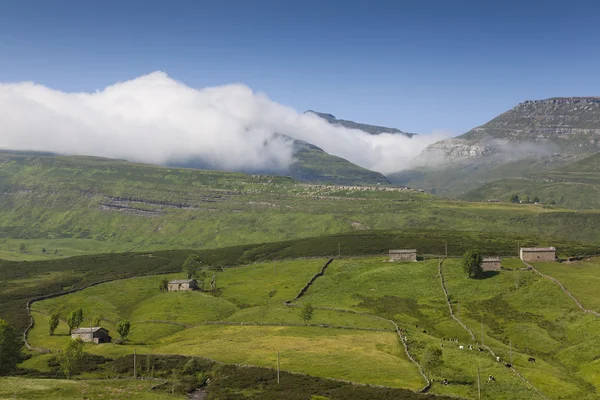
[{"xmin": 423, "ymin": 97, "xmax": 600, "ymax": 162}]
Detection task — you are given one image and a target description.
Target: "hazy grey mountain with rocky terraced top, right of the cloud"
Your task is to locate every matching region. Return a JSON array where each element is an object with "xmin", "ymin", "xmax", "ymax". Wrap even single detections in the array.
[{"xmin": 388, "ymin": 97, "xmax": 600, "ymax": 197}]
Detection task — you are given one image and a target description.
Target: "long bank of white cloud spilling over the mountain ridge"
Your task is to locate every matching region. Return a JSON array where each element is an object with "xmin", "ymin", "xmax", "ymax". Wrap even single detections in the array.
[{"xmin": 0, "ymin": 72, "xmax": 448, "ymax": 173}]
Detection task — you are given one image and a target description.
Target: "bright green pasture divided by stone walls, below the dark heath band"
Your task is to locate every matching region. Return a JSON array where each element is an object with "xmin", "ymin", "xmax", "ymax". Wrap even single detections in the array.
[{"xmin": 23, "ymin": 256, "xmax": 600, "ymax": 399}]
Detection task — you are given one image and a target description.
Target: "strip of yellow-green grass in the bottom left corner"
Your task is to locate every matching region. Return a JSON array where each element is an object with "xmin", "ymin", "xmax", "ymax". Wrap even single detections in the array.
[{"xmin": 0, "ymin": 378, "xmax": 185, "ymax": 400}]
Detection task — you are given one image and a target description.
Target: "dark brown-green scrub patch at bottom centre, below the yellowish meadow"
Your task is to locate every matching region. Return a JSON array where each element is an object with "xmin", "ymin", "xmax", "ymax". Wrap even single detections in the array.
[{"xmin": 207, "ymin": 365, "xmax": 449, "ymax": 400}]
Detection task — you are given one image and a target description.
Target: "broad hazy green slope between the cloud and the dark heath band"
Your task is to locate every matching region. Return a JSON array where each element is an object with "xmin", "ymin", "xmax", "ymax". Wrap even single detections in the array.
[{"xmin": 0, "ymin": 154, "xmax": 600, "ymax": 258}]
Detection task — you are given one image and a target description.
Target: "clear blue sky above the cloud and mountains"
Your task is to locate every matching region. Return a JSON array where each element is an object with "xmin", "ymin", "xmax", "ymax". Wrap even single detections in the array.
[{"xmin": 0, "ymin": 0, "xmax": 600, "ymax": 134}]
